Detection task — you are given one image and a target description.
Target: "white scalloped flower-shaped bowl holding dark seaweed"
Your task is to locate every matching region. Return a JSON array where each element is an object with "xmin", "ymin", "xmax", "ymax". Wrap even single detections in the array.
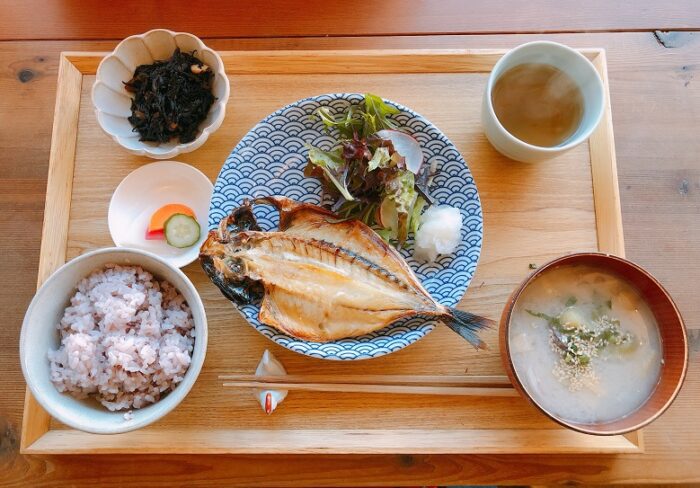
[{"xmin": 92, "ymin": 29, "xmax": 230, "ymax": 159}]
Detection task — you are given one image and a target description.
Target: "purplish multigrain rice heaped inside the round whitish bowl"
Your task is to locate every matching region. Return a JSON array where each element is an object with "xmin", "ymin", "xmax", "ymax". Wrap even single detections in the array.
[{"xmin": 49, "ymin": 264, "xmax": 195, "ymax": 410}]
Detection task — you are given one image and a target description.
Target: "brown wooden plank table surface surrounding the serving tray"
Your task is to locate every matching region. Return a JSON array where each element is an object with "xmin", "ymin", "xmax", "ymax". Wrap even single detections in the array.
[{"xmin": 0, "ymin": 0, "xmax": 700, "ymax": 486}]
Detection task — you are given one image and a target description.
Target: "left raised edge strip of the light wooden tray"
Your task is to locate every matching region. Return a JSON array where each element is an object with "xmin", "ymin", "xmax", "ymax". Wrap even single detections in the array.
[{"xmin": 22, "ymin": 52, "xmax": 83, "ymax": 448}]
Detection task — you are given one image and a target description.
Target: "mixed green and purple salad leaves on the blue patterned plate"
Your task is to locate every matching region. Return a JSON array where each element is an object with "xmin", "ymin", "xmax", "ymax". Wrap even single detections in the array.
[{"xmin": 304, "ymin": 93, "xmax": 431, "ymax": 245}]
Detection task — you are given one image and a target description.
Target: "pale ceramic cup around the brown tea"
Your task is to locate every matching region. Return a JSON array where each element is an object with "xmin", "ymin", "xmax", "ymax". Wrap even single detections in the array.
[{"xmin": 481, "ymin": 41, "xmax": 605, "ymax": 163}]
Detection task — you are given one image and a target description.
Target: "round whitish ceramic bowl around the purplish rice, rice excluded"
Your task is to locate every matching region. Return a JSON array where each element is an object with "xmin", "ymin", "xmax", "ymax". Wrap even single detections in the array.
[{"xmin": 19, "ymin": 248, "xmax": 207, "ymax": 434}]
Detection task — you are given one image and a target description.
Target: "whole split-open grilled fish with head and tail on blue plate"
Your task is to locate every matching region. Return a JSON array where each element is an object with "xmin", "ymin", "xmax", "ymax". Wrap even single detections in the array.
[{"xmin": 199, "ymin": 197, "xmax": 493, "ymax": 349}]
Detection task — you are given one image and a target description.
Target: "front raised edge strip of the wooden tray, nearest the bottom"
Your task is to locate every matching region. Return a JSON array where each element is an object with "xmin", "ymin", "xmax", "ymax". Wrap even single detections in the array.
[{"xmin": 26, "ymin": 429, "xmax": 637, "ymax": 455}]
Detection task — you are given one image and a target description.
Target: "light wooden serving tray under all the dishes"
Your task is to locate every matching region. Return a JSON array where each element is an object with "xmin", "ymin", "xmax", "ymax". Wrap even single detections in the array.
[{"xmin": 22, "ymin": 50, "xmax": 641, "ymax": 454}]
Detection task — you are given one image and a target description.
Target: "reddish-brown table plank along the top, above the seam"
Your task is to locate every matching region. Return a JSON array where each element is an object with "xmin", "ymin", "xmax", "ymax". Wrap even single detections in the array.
[{"xmin": 0, "ymin": 0, "xmax": 700, "ymax": 39}]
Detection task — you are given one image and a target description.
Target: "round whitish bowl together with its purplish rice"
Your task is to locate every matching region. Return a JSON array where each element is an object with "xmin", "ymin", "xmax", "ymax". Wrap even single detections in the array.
[{"xmin": 19, "ymin": 247, "xmax": 208, "ymax": 434}]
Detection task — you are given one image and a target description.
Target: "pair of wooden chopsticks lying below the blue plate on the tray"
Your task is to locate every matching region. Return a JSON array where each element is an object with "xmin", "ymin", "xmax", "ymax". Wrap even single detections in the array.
[{"xmin": 219, "ymin": 374, "xmax": 517, "ymax": 396}]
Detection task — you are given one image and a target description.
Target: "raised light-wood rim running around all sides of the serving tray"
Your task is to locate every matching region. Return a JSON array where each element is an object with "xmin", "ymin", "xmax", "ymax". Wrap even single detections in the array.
[{"xmin": 21, "ymin": 49, "xmax": 643, "ymax": 454}]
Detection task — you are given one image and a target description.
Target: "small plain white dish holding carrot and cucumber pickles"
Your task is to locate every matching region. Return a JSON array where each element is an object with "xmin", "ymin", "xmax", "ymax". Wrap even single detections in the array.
[{"xmin": 107, "ymin": 161, "xmax": 214, "ymax": 268}]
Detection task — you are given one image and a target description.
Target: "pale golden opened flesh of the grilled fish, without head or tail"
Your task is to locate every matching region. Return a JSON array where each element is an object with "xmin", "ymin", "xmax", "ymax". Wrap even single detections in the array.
[{"xmin": 228, "ymin": 232, "xmax": 445, "ymax": 342}]
